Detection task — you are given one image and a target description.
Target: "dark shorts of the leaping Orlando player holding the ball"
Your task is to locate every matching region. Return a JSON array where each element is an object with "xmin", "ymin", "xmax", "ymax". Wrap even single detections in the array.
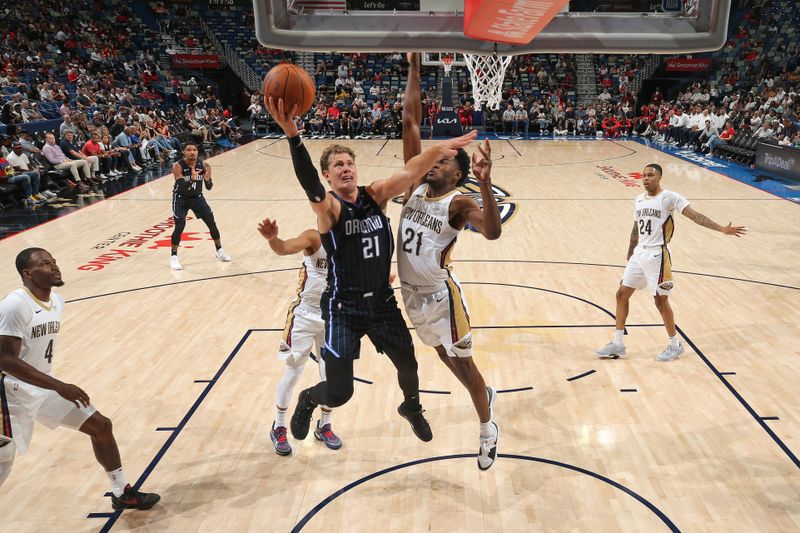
[{"xmin": 320, "ymin": 286, "xmax": 414, "ymax": 360}]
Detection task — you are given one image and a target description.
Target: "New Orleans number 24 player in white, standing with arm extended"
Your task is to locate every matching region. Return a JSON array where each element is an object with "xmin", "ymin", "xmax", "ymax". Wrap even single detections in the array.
[{"xmin": 595, "ymin": 163, "xmax": 746, "ymax": 362}]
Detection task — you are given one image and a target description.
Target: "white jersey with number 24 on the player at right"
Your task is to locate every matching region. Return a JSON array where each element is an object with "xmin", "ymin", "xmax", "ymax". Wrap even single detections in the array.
[{"xmin": 633, "ymin": 190, "xmax": 689, "ymax": 246}]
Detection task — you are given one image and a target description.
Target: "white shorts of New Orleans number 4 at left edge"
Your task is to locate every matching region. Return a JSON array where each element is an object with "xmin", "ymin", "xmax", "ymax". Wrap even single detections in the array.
[{"xmin": 0, "ymin": 376, "xmax": 97, "ymax": 454}]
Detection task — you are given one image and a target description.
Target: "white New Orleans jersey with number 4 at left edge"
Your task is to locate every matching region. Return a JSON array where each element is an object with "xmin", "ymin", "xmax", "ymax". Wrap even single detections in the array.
[{"xmin": 0, "ymin": 288, "xmax": 64, "ymax": 375}]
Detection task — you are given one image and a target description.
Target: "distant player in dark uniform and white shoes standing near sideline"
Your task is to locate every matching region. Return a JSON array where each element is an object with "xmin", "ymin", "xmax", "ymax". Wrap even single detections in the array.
[{"xmin": 169, "ymin": 142, "xmax": 231, "ymax": 270}]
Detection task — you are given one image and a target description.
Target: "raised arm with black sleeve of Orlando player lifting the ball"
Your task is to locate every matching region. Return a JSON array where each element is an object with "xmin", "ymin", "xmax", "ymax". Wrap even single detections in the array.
[{"xmin": 267, "ymin": 96, "xmax": 341, "ymax": 233}]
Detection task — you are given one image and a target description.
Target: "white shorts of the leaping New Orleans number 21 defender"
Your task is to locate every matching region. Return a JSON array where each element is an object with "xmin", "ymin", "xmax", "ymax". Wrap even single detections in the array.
[{"xmin": 402, "ymin": 274, "xmax": 472, "ymax": 357}]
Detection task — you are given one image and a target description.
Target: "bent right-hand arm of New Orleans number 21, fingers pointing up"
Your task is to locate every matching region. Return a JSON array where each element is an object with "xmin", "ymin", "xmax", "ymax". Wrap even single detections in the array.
[{"xmin": 453, "ymin": 140, "xmax": 496, "ymax": 241}]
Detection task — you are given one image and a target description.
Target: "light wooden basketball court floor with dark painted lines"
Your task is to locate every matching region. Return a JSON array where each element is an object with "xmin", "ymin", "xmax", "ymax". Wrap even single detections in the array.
[{"xmin": 0, "ymin": 139, "xmax": 800, "ymax": 533}]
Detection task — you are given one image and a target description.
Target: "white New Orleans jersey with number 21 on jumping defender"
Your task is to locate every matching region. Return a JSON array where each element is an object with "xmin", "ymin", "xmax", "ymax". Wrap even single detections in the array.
[{"xmin": 397, "ymin": 184, "xmax": 461, "ymax": 289}]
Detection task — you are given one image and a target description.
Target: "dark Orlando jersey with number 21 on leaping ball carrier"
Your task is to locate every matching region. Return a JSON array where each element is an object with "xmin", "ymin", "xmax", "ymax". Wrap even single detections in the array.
[{"xmin": 321, "ymin": 186, "xmax": 394, "ymax": 298}]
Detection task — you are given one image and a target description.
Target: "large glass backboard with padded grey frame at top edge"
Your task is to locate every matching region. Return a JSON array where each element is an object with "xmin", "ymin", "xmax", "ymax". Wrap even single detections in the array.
[{"xmin": 253, "ymin": 0, "xmax": 731, "ymax": 55}]
